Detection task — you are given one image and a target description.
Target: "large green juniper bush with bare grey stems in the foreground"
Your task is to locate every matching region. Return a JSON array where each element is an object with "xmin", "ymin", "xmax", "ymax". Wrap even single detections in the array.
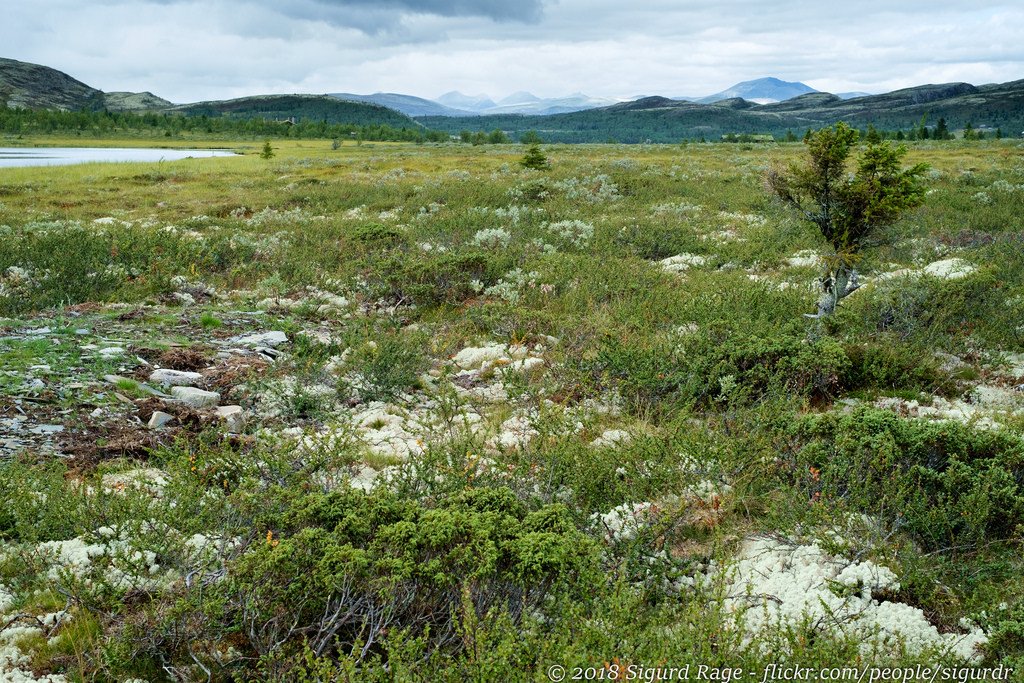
[{"xmin": 228, "ymin": 488, "xmax": 597, "ymax": 658}]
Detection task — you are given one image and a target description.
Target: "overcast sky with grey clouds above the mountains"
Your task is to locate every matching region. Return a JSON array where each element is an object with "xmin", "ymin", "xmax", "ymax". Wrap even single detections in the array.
[{"xmin": 0, "ymin": 0, "xmax": 1024, "ymax": 102}]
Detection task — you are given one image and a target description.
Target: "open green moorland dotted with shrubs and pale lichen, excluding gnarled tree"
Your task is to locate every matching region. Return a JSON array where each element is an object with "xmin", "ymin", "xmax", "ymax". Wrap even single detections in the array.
[{"xmin": 0, "ymin": 139, "xmax": 1024, "ymax": 683}]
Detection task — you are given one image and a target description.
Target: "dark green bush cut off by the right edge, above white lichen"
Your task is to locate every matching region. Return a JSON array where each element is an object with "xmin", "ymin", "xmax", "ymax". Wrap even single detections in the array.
[{"xmin": 794, "ymin": 408, "xmax": 1024, "ymax": 550}]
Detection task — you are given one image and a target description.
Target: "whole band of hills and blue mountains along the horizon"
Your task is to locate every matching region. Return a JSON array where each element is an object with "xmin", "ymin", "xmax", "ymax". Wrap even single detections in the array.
[{"xmin": 0, "ymin": 58, "xmax": 1024, "ymax": 142}]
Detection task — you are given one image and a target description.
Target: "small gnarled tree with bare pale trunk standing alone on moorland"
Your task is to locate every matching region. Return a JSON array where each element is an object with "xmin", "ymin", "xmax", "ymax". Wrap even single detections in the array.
[{"xmin": 766, "ymin": 122, "xmax": 928, "ymax": 317}]
